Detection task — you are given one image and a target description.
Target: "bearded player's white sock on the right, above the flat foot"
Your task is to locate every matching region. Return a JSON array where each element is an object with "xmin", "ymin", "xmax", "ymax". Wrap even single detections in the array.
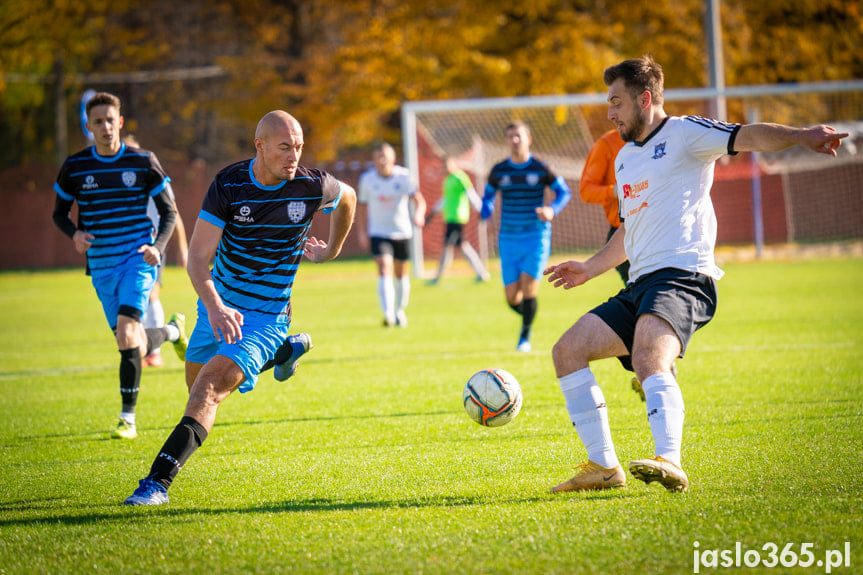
[{"xmin": 641, "ymin": 373, "xmax": 685, "ymax": 467}]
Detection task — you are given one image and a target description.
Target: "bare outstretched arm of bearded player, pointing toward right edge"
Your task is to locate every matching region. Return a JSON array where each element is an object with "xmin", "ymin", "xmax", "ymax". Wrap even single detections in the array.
[{"xmin": 734, "ymin": 123, "xmax": 849, "ymax": 156}]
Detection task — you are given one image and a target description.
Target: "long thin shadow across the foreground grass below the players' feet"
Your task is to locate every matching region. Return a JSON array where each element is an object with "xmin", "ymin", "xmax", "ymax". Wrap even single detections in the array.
[{"xmin": 0, "ymin": 489, "xmax": 648, "ymax": 527}]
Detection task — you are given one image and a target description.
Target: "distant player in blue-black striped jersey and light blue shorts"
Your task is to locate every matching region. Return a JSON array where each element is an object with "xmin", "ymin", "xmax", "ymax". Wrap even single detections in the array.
[{"xmin": 480, "ymin": 121, "xmax": 572, "ymax": 352}]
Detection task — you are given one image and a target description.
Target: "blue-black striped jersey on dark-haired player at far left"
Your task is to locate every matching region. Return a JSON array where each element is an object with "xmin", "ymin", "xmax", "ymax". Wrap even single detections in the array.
[{"xmin": 54, "ymin": 144, "xmax": 171, "ymax": 271}]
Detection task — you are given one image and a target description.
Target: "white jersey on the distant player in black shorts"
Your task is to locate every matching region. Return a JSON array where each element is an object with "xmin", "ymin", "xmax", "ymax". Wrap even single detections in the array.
[{"xmin": 357, "ymin": 166, "xmax": 416, "ymax": 240}]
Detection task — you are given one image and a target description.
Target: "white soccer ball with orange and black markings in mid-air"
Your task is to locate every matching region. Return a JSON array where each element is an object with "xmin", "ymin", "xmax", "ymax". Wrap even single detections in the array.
[{"xmin": 462, "ymin": 369, "xmax": 522, "ymax": 427}]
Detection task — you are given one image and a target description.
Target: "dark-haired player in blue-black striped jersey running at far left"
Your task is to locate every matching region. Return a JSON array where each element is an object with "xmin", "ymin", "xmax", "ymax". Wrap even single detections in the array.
[{"xmin": 53, "ymin": 92, "xmax": 186, "ymax": 439}]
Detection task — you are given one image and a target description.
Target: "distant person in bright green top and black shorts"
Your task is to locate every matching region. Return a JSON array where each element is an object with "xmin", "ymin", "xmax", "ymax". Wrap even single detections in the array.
[{"xmin": 425, "ymin": 156, "xmax": 489, "ymax": 285}]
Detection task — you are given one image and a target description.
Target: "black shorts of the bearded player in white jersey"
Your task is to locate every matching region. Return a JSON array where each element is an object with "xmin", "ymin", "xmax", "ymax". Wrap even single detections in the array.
[{"xmin": 591, "ymin": 268, "xmax": 716, "ymax": 371}]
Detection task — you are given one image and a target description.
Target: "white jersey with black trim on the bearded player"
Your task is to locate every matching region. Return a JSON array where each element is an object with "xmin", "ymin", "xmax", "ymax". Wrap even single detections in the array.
[{"xmin": 614, "ymin": 116, "xmax": 740, "ymax": 283}]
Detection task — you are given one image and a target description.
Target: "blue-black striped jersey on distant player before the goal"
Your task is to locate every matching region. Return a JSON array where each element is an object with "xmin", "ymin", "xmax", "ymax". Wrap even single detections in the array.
[{"xmin": 484, "ymin": 156, "xmax": 557, "ymax": 232}]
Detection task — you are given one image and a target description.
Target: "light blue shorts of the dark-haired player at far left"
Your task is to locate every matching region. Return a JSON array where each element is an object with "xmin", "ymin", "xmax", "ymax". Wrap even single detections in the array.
[{"xmin": 90, "ymin": 254, "xmax": 159, "ymax": 329}]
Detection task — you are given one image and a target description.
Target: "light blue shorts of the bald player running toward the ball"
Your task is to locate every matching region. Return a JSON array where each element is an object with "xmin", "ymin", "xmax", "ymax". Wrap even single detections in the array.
[{"xmin": 186, "ymin": 300, "xmax": 291, "ymax": 393}]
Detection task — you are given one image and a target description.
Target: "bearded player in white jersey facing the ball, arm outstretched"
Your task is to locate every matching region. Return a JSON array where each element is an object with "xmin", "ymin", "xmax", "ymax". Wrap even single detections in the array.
[{"xmin": 544, "ymin": 56, "xmax": 848, "ymax": 492}]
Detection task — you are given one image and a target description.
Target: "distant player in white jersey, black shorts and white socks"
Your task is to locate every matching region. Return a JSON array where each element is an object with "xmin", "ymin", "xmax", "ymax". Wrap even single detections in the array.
[{"xmin": 357, "ymin": 143, "xmax": 426, "ymax": 327}]
